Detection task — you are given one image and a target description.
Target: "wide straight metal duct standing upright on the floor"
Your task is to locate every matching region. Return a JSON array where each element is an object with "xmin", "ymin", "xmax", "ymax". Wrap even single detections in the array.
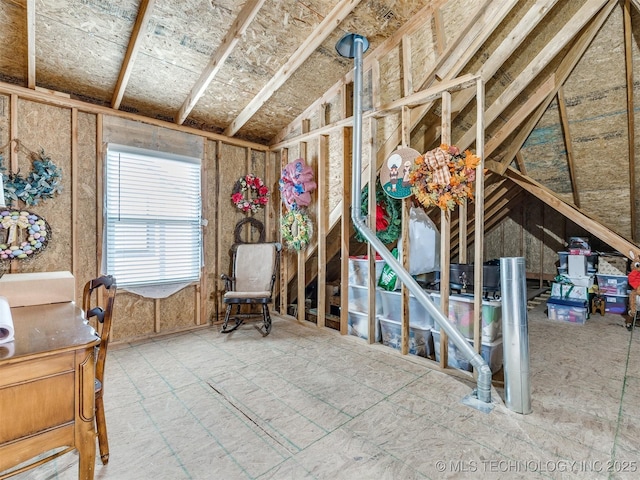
[{"xmin": 500, "ymin": 257, "xmax": 531, "ymax": 414}]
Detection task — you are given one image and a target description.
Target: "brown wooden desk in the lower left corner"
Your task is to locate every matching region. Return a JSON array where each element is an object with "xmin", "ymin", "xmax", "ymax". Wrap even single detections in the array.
[{"xmin": 0, "ymin": 302, "xmax": 99, "ymax": 480}]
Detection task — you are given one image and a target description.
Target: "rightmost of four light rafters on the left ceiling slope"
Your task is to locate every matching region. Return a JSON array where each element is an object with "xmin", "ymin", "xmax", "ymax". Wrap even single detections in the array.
[{"xmin": 224, "ymin": 0, "xmax": 361, "ymax": 137}]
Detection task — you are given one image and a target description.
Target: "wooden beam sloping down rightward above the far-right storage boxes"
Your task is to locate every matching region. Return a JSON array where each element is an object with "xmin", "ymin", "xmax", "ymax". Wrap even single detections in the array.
[{"xmin": 505, "ymin": 167, "xmax": 640, "ymax": 258}]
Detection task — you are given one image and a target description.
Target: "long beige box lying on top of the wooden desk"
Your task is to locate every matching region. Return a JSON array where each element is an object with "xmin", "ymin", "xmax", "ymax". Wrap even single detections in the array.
[{"xmin": 0, "ymin": 272, "xmax": 76, "ymax": 307}]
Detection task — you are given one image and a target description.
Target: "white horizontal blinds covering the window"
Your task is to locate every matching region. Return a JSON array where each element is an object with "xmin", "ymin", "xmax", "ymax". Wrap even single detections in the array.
[{"xmin": 105, "ymin": 144, "xmax": 202, "ymax": 286}]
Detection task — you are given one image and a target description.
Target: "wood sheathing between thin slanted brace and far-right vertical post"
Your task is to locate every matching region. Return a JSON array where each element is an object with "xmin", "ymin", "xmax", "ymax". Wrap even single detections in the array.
[{"xmin": 564, "ymin": 8, "xmax": 631, "ymax": 235}]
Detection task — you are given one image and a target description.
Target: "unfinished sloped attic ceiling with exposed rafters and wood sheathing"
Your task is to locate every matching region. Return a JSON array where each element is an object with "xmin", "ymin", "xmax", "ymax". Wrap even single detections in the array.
[{"xmin": 0, "ymin": 0, "xmax": 640, "ymax": 251}]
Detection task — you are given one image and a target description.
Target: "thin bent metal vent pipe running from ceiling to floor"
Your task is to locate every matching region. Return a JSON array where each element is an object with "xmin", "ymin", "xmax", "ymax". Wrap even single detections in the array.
[{"xmin": 336, "ymin": 33, "xmax": 491, "ymax": 411}]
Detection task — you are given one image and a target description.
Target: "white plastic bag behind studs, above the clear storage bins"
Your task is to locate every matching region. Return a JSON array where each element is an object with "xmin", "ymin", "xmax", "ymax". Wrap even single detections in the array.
[{"xmin": 409, "ymin": 207, "xmax": 440, "ymax": 275}]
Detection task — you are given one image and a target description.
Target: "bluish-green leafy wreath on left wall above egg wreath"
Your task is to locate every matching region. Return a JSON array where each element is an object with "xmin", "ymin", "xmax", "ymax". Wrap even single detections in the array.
[{"xmin": 0, "ymin": 145, "xmax": 62, "ymax": 205}]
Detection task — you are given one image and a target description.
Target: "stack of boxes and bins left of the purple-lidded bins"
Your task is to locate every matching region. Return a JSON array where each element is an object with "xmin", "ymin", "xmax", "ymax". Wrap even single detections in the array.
[{"xmin": 547, "ymin": 237, "xmax": 598, "ymax": 325}]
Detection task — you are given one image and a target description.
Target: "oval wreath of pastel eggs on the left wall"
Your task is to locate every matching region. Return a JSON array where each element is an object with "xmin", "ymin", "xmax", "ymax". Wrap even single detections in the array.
[{"xmin": 0, "ymin": 208, "xmax": 51, "ymax": 260}]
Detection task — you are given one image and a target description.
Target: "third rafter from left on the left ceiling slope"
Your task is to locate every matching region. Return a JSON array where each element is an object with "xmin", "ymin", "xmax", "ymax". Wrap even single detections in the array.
[{"xmin": 175, "ymin": 0, "xmax": 266, "ymax": 125}]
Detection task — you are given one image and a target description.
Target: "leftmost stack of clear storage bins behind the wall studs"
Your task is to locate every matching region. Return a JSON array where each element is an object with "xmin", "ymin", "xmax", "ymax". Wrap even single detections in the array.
[{"xmin": 349, "ymin": 255, "xmax": 385, "ymax": 341}]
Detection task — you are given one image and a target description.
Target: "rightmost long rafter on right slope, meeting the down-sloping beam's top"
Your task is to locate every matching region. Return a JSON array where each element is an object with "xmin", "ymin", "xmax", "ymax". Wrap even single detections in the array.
[{"xmin": 487, "ymin": 0, "xmax": 617, "ymax": 174}]
